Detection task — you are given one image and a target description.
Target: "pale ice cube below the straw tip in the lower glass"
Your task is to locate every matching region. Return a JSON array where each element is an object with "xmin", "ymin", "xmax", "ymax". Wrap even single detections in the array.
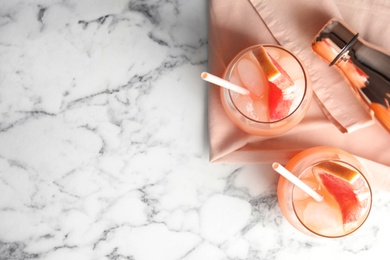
[{"xmin": 302, "ymin": 200, "xmax": 344, "ymax": 236}]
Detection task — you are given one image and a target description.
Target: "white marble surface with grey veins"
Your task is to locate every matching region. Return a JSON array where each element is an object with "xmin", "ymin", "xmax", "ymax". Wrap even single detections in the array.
[{"xmin": 0, "ymin": 0, "xmax": 390, "ymax": 260}]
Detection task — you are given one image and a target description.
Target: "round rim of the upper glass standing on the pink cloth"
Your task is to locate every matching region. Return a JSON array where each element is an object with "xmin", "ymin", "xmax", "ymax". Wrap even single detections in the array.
[{"xmin": 225, "ymin": 44, "xmax": 308, "ymax": 125}]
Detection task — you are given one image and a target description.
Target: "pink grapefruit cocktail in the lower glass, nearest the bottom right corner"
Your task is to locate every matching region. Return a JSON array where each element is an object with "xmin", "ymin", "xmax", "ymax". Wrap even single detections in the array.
[{"xmin": 278, "ymin": 147, "xmax": 372, "ymax": 238}]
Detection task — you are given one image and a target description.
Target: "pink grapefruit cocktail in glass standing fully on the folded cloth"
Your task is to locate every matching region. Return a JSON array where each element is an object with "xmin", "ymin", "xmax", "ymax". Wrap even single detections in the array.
[{"xmin": 220, "ymin": 45, "xmax": 312, "ymax": 136}]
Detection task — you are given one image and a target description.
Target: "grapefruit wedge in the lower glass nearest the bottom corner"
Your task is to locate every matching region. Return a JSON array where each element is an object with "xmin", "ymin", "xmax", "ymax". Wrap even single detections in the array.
[{"xmin": 313, "ymin": 162, "xmax": 362, "ymax": 224}]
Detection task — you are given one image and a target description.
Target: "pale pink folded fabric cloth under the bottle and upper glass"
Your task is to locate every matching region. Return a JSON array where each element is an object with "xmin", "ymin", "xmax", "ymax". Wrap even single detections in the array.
[{"xmin": 208, "ymin": 0, "xmax": 390, "ymax": 189}]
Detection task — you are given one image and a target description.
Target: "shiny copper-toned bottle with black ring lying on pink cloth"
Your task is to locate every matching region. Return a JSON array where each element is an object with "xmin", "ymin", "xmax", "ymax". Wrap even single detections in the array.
[{"xmin": 312, "ymin": 18, "xmax": 390, "ymax": 132}]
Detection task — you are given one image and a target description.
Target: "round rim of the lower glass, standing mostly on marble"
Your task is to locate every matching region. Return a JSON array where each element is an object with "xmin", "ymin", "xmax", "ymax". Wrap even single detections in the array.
[{"xmin": 291, "ymin": 159, "xmax": 372, "ymax": 238}]
